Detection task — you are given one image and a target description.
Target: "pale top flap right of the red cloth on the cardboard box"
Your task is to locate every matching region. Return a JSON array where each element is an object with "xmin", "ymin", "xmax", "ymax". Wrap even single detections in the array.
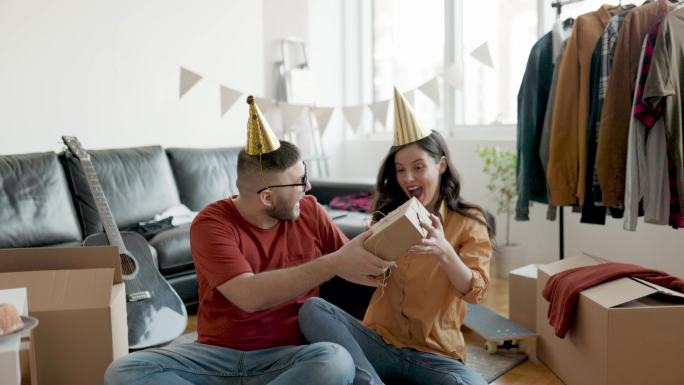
[{"xmin": 582, "ymin": 278, "xmax": 657, "ymax": 308}]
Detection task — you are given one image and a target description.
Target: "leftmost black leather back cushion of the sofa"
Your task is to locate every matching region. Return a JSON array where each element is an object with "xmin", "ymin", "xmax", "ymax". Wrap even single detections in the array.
[{"xmin": 0, "ymin": 152, "xmax": 82, "ymax": 248}]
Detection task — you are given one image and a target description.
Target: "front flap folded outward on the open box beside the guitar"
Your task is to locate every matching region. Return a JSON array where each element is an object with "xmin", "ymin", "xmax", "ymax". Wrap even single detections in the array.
[{"xmin": 0, "ymin": 268, "xmax": 114, "ymax": 312}]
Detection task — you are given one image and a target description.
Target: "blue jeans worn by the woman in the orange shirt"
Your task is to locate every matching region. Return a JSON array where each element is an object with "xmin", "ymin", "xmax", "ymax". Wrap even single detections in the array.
[{"xmin": 299, "ymin": 297, "xmax": 487, "ymax": 385}]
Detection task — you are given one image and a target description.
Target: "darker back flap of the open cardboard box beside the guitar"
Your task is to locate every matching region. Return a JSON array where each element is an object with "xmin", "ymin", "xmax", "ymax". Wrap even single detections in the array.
[{"xmin": 0, "ymin": 246, "xmax": 122, "ymax": 283}]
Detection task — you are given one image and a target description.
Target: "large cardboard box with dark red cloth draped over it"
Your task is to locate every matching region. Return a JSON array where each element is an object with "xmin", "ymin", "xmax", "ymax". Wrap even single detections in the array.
[{"xmin": 536, "ymin": 255, "xmax": 684, "ymax": 385}]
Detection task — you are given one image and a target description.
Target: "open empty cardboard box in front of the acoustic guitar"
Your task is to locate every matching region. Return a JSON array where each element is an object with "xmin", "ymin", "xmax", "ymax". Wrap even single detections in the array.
[{"xmin": 0, "ymin": 246, "xmax": 128, "ymax": 385}]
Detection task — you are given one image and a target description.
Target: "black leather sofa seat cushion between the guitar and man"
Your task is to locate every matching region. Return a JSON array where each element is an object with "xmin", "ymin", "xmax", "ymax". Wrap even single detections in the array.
[{"xmin": 150, "ymin": 224, "xmax": 195, "ymax": 275}]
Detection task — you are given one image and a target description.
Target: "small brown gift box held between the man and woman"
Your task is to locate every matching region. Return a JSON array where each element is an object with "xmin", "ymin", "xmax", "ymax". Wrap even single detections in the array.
[{"xmin": 363, "ymin": 197, "xmax": 431, "ymax": 261}]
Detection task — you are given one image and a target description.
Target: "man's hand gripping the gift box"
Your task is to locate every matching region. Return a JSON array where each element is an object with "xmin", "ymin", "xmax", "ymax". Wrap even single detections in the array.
[{"xmin": 334, "ymin": 230, "xmax": 395, "ymax": 278}]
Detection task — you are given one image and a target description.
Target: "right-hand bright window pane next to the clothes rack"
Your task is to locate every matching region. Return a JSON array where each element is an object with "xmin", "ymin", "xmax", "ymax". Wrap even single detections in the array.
[{"xmin": 455, "ymin": 0, "xmax": 538, "ymax": 125}]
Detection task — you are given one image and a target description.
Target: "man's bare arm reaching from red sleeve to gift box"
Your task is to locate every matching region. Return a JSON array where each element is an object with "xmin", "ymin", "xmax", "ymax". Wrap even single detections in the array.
[{"xmin": 217, "ymin": 231, "xmax": 394, "ymax": 312}]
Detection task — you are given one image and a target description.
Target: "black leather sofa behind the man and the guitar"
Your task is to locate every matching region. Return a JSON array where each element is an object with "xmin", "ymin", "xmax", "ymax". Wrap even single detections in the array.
[{"xmin": 0, "ymin": 146, "xmax": 372, "ymax": 314}]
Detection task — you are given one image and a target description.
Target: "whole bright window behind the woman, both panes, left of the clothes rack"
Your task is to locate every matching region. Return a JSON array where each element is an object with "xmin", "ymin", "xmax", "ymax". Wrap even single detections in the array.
[{"xmin": 370, "ymin": 0, "xmax": 616, "ymax": 133}]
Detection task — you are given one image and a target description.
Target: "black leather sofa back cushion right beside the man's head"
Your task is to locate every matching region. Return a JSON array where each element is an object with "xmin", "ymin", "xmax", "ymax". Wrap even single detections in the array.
[{"xmin": 166, "ymin": 147, "xmax": 241, "ymax": 211}]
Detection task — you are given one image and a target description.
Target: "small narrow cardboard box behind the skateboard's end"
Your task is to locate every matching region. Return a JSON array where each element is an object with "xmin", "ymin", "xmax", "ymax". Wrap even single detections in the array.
[{"xmin": 508, "ymin": 264, "xmax": 537, "ymax": 332}]
